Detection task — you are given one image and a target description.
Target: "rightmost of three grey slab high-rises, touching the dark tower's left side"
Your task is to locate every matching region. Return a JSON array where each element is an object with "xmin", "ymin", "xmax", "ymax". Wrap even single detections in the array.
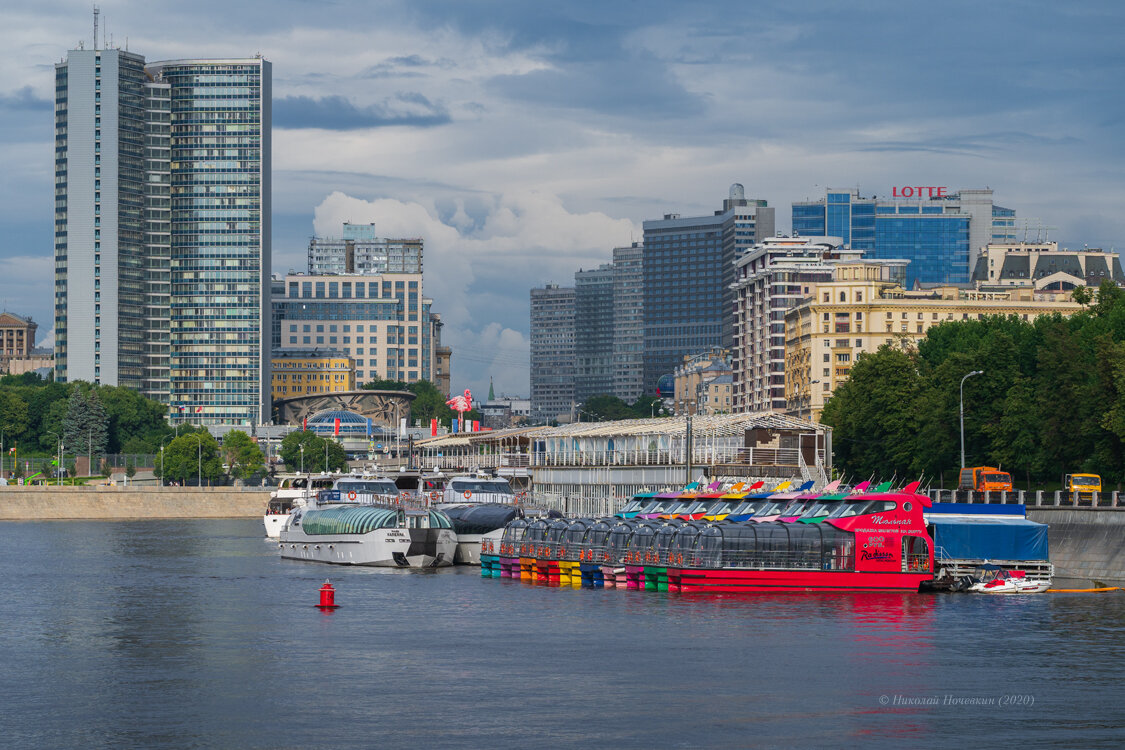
[{"xmin": 611, "ymin": 242, "xmax": 645, "ymax": 404}]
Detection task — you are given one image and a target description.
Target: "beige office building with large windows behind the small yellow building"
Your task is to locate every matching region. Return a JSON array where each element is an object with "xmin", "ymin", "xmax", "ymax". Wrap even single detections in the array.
[{"xmin": 272, "ymin": 273, "xmax": 436, "ymax": 387}]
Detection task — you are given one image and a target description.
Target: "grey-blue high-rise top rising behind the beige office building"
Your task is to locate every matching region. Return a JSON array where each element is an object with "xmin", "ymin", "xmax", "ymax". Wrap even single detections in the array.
[{"xmin": 308, "ymin": 223, "xmax": 422, "ymax": 275}]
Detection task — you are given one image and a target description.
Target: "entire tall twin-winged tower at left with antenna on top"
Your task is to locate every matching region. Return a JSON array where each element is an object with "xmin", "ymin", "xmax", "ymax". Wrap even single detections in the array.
[{"xmin": 55, "ymin": 39, "xmax": 271, "ymax": 424}]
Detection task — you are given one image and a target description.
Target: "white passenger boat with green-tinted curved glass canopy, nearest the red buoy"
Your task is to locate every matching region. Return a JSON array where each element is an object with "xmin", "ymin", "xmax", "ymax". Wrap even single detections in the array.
[{"xmin": 278, "ymin": 477, "xmax": 457, "ymax": 568}]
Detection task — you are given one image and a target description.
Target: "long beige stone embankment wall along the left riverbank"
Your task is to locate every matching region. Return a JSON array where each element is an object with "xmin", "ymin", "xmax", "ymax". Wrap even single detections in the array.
[{"xmin": 0, "ymin": 487, "xmax": 270, "ymax": 521}]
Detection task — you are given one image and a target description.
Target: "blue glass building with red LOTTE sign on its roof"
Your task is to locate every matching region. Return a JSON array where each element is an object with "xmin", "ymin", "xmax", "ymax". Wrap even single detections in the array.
[{"xmin": 793, "ymin": 187, "xmax": 1016, "ymax": 286}]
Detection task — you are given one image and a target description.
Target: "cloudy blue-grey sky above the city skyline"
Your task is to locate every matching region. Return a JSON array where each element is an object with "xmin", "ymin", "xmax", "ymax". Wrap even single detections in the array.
[{"xmin": 0, "ymin": 0, "xmax": 1125, "ymax": 396}]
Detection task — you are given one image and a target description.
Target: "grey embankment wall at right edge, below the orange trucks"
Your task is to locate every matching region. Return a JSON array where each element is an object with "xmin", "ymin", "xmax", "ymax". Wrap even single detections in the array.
[{"xmin": 1027, "ymin": 507, "xmax": 1125, "ymax": 586}]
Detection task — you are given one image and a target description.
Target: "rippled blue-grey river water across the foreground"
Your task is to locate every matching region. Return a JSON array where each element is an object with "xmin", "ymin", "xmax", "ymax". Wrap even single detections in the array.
[{"xmin": 0, "ymin": 521, "xmax": 1125, "ymax": 750}]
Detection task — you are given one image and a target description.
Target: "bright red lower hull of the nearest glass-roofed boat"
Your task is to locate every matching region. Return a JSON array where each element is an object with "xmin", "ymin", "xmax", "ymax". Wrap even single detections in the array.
[{"xmin": 668, "ymin": 569, "xmax": 934, "ymax": 593}]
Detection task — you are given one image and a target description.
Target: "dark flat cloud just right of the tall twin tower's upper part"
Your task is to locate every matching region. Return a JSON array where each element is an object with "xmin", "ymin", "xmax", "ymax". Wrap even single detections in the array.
[{"xmin": 273, "ymin": 92, "xmax": 452, "ymax": 130}]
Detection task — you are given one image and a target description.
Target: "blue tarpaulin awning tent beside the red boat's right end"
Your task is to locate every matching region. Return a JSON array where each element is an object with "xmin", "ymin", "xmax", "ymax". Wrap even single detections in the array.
[{"xmin": 927, "ymin": 515, "xmax": 1050, "ymax": 561}]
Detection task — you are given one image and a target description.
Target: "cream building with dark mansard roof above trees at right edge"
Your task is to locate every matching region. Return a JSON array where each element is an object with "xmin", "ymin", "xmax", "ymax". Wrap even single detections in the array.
[{"xmin": 972, "ymin": 242, "xmax": 1125, "ymax": 291}]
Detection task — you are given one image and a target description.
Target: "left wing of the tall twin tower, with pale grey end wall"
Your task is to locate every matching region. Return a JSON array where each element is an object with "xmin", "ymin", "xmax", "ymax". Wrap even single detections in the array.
[{"xmin": 54, "ymin": 48, "xmax": 145, "ymax": 389}]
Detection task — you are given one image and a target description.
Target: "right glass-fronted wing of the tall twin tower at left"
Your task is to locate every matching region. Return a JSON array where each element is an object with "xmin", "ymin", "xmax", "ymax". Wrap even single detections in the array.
[{"xmin": 146, "ymin": 57, "xmax": 271, "ymax": 424}]
